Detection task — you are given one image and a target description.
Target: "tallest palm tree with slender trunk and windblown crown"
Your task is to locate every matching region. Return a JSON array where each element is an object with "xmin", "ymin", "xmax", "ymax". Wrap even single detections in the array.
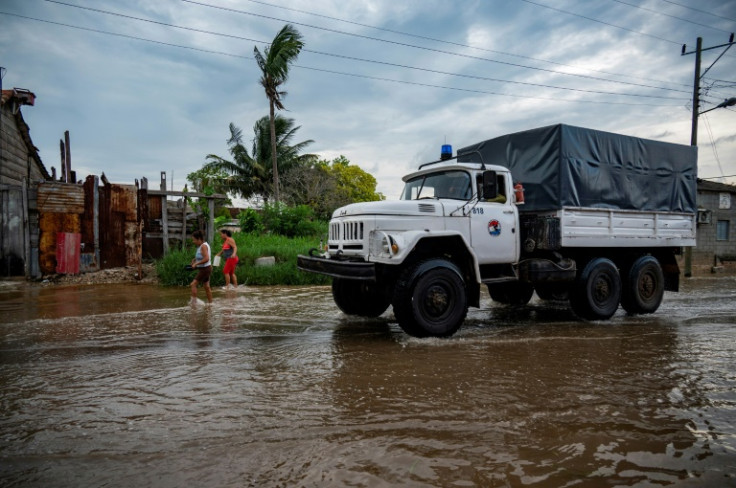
[{"xmin": 253, "ymin": 24, "xmax": 304, "ymax": 202}]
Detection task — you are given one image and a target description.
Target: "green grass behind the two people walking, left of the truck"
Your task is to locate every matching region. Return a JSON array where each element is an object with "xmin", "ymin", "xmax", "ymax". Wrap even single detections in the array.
[{"xmin": 156, "ymin": 232, "xmax": 330, "ymax": 286}]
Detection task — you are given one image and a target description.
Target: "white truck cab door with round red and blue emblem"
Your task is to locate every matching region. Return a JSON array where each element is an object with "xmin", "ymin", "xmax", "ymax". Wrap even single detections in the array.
[{"xmin": 470, "ymin": 174, "xmax": 519, "ymax": 264}]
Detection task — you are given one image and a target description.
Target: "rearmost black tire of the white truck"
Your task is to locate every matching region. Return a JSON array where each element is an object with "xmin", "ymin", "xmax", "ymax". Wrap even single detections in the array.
[{"xmin": 621, "ymin": 256, "xmax": 664, "ymax": 314}]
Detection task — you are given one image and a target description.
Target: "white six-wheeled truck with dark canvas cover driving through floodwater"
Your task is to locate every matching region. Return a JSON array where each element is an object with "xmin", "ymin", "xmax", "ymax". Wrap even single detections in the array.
[{"xmin": 297, "ymin": 124, "xmax": 697, "ymax": 337}]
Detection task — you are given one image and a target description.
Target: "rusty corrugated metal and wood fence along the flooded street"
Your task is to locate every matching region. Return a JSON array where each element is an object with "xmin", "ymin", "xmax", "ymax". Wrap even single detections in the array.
[{"xmin": 0, "ymin": 175, "xmax": 225, "ymax": 278}]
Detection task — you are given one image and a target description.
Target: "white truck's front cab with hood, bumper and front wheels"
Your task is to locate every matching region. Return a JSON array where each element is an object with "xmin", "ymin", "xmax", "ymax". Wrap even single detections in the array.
[{"xmin": 297, "ymin": 158, "xmax": 536, "ymax": 336}]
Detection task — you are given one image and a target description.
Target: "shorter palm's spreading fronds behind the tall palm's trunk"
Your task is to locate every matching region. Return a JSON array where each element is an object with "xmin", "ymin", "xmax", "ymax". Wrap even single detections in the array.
[{"xmin": 202, "ymin": 115, "xmax": 316, "ymax": 200}]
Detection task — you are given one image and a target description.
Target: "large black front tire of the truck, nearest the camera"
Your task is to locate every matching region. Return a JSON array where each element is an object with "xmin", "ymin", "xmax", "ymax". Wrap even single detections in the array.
[{"xmin": 392, "ymin": 259, "xmax": 468, "ymax": 337}]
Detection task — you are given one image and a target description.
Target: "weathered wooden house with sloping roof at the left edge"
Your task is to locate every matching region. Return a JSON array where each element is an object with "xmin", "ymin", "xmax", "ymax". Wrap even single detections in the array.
[{"xmin": 0, "ymin": 88, "xmax": 51, "ymax": 276}]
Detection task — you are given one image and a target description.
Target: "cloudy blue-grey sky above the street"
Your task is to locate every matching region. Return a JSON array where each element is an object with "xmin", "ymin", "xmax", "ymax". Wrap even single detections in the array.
[{"xmin": 0, "ymin": 0, "xmax": 736, "ymax": 199}]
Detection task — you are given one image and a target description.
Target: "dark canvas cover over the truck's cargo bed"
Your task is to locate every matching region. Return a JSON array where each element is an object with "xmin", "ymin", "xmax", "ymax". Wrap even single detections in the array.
[{"xmin": 457, "ymin": 124, "xmax": 698, "ymax": 213}]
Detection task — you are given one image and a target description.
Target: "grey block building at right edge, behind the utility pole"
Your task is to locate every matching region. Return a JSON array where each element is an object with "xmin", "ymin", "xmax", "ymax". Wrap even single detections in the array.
[{"xmin": 693, "ymin": 180, "xmax": 736, "ymax": 272}]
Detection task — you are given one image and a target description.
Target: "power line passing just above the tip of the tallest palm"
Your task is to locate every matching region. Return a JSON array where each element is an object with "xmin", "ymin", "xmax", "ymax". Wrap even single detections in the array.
[{"xmin": 181, "ymin": 0, "xmax": 690, "ymax": 93}]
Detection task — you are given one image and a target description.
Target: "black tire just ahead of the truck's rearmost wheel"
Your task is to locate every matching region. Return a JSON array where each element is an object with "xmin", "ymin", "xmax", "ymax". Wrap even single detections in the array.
[{"xmin": 570, "ymin": 258, "xmax": 621, "ymax": 320}]
